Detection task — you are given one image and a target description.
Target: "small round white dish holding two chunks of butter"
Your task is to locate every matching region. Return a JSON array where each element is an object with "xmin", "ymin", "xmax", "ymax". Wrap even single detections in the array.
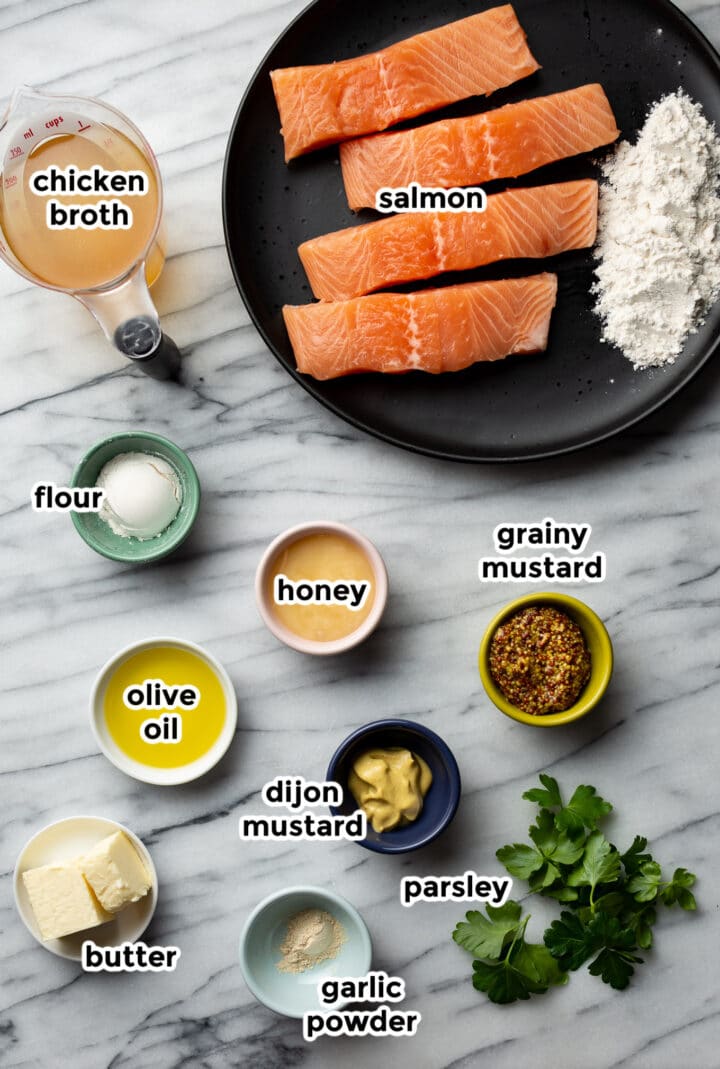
[{"xmin": 13, "ymin": 817, "xmax": 158, "ymax": 961}]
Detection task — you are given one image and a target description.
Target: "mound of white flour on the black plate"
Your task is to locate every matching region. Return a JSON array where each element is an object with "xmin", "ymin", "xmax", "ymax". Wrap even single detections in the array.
[{"xmin": 593, "ymin": 91, "xmax": 720, "ymax": 368}]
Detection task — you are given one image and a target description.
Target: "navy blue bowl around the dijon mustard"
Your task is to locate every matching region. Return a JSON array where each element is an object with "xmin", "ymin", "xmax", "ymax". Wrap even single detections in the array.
[{"xmin": 326, "ymin": 721, "xmax": 460, "ymax": 854}]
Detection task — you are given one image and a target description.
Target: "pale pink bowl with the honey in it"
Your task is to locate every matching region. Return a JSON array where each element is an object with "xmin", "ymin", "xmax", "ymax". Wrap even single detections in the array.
[{"xmin": 255, "ymin": 522, "xmax": 388, "ymax": 656}]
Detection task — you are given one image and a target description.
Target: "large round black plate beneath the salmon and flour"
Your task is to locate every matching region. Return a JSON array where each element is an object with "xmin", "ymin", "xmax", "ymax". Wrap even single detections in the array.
[{"xmin": 223, "ymin": 0, "xmax": 720, "ymax": 461}]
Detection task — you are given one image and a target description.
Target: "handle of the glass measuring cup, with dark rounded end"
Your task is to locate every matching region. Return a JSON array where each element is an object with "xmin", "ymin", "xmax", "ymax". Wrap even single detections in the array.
[{"xmin": 75, "ymin": 263, "xmax": 181, "ymax": 379}]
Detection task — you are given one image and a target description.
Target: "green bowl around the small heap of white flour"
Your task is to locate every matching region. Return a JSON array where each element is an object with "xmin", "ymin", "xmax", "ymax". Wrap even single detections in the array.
[{"xmin": 71, "ymin": 431, "xmax": 200, "ymax": 564}]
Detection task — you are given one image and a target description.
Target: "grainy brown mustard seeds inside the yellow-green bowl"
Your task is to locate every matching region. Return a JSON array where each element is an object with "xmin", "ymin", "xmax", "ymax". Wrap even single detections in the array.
[{"xmin": 490, "ymin": 605, "xmax": 591, "ymax": 716}]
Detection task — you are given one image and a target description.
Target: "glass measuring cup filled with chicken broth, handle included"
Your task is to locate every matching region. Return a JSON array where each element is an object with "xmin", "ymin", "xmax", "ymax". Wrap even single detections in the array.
[{"xmin": 0, "ymin": 86, "xmax": 179, "ymax": 378}]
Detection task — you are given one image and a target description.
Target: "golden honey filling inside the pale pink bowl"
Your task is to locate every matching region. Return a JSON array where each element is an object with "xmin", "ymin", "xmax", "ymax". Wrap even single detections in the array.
[{"xmin": 265, "ymin": 530, "xmax": 376, "ymax": 642}]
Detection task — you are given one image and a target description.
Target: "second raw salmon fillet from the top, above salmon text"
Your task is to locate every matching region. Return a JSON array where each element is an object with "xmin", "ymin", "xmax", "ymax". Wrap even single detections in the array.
[{"xmin": 340, "ymin": 84, "xmax": 620, "ymax": 208}]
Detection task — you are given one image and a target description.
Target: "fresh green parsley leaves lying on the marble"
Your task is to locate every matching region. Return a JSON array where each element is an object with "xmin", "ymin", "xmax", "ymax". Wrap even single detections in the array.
[{"xmin": 453, "ymin": 773, "xmax": 695, "ymax": 1003}]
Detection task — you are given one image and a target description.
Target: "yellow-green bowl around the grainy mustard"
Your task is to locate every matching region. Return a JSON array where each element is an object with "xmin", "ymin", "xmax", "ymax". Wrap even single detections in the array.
[{"xmin": 478, "ymin": 593, "xmax": 612, "ymax": 728}]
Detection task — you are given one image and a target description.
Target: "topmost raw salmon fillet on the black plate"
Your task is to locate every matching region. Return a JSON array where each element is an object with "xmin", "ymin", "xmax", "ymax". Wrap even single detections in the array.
[{"xmin": 270, "ymin": 4, "xmax": 538, "ymax": 160}]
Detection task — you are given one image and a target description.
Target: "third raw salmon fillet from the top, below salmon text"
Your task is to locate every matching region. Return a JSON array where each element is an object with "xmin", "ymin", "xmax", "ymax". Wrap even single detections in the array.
[{"xmin": 298, "ymin": 180, "xmax": 597, "ymax": 300}]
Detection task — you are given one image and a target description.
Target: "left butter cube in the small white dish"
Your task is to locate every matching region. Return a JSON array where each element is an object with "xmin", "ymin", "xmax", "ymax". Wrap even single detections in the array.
[{"xmin": 22, "ymin": 862, "xmax": 112, "ymax": 941}]
